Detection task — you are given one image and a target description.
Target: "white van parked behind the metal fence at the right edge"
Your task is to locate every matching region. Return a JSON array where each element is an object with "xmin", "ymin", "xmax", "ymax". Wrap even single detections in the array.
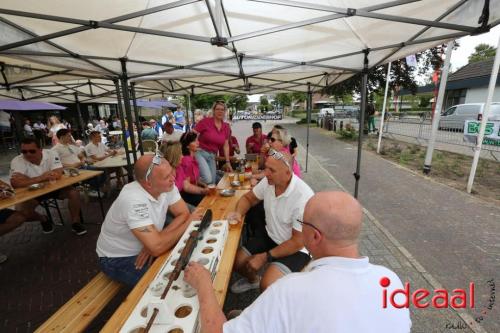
[{"xmin": 439, "ymin": 102, "xmax": 500, "ymax": 131}]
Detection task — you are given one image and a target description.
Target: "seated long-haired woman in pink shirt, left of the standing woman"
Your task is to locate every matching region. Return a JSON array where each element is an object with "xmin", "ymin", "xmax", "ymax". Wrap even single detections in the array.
[{"xmin": 175, "ymin": 132, "xmax": 208, "ymax": 206}]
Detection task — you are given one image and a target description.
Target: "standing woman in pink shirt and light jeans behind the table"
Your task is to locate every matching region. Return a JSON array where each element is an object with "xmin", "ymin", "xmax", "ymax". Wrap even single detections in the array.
[{"xmin": 194, "ymin": 101, "xmax": 232, "ymax": 184}]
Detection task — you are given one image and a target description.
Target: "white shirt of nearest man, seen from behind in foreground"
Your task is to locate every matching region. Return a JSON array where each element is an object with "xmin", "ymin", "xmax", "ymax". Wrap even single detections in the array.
[{"xmin": 223, "ymin": 257, "xmax": 411, "ymax": 333}]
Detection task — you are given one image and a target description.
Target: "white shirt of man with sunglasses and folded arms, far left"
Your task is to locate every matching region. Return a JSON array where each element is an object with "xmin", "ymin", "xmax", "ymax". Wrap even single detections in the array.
[{"xmin": 10, "ymin": 149, "xmax": 63, "ymax": 178}]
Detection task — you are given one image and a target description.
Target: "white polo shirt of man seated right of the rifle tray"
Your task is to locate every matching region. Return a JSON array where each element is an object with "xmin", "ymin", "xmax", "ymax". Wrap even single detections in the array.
[{"xmin": 253, "ymin": 174, "xmax": 314, "ymax": 248}]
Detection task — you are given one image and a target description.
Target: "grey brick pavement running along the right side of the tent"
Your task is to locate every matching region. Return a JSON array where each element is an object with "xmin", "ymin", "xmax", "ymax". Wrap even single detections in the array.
[{"xmin": 288, "ymin": 120, "xmax": 500, "ymax": 332}]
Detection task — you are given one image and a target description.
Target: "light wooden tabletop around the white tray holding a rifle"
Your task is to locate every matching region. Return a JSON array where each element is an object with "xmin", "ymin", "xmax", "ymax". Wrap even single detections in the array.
[{"xmin": 101, "ymin": 174, "xmax": 248, "ymax": 333}]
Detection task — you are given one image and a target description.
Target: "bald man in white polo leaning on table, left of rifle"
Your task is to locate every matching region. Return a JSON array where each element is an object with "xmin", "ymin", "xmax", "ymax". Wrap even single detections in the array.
[{"xmin": 96, "ymin": 155, "xmax": 190, "ymax": 286}]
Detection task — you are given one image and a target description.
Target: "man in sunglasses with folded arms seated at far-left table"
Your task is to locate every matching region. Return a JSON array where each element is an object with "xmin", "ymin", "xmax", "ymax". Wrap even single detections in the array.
[{"xmin": 10, "ymin": 138, "xmax": 87, "ymax": 236}]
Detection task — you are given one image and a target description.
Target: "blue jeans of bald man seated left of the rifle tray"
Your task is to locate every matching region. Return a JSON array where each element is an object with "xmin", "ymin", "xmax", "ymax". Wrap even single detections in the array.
[{"xmin": 98, "ymin": 256, "xmax": 149, "ymax": 287}]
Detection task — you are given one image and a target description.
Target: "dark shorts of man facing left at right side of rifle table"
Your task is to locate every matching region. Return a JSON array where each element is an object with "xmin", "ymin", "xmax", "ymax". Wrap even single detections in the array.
[{"xmin": 242, "ymin": 226, "xmax": 311, "ymax": 275}]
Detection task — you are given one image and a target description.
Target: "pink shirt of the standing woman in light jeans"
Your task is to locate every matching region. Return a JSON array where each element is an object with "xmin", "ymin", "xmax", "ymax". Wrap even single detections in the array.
[{"xmin": 194, "ymin": 117, "xmax": 231, "ymax": 154}]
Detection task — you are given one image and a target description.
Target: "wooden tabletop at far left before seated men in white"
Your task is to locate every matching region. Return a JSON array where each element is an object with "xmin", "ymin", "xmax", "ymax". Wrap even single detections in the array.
[{"xmin": 0, "ymin": 170, "xmax": 103, "ymax": 209}]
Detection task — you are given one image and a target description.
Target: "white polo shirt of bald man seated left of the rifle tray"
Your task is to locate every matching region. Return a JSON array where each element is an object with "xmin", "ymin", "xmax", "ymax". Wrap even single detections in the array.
[{"xmin": 96, "ymin": 181, "xmax": 181, "ymax": 257}]
